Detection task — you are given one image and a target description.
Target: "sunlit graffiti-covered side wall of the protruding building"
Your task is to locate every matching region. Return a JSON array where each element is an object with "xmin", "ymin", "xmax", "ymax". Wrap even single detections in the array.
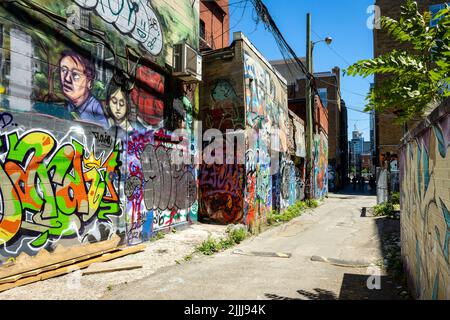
[{"xmin": 244, "ymin": 44, "xmax": 291, "ymax": 227}]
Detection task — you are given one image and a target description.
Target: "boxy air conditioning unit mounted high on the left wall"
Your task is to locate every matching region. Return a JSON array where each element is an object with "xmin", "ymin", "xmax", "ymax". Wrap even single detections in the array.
[{"xmin": 173, "ymin": 43, "xmax": 202, "ymax": 82}]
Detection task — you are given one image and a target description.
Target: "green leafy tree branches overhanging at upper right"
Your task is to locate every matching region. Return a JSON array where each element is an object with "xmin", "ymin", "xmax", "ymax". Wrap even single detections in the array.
[{"xmin": 345, "ymin": 0, "xmax": 450, "ymax": 123}]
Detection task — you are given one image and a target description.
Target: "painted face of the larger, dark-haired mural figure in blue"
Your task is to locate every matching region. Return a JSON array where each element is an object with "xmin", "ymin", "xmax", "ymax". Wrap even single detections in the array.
[{"xmin": 60, "ymin": 56, "xmax": 92, "ymax": 106}]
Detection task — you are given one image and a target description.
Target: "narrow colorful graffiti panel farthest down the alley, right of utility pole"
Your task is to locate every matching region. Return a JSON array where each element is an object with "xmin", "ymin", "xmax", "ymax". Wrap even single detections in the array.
[{"xmin": 313, "ymin": 132, "xmax": 328, "ymax": 199}]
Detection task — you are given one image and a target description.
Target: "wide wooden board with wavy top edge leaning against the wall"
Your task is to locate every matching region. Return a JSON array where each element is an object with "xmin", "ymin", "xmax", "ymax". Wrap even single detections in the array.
[{"xmin": 0, "ymin": 235, "xmax": 120, "ymax": 279}]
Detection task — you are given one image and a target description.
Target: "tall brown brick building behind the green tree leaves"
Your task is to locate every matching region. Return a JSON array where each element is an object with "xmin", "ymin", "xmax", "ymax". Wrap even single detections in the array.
[{"xmin": 374, "ymin": 0, "xmax": 445, "ymax": 166}]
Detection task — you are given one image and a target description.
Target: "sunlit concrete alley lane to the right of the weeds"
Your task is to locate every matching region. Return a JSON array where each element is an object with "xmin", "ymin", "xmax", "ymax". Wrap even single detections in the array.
[{"xmin": 102, "ymin": 191, "xmax": 404, "ymax": 300}]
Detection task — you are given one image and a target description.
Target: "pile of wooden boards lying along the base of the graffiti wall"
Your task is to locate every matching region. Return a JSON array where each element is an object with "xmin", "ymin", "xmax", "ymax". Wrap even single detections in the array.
[{"xmin": 0, "ymin": 235, "xmax": 146, "ymax": 292}]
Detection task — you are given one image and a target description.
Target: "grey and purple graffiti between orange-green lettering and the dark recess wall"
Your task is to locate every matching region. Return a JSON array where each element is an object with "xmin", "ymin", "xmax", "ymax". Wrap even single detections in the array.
[{"xmin": 125, "ymin": 131, "xmax": 197, "ymax": 243}]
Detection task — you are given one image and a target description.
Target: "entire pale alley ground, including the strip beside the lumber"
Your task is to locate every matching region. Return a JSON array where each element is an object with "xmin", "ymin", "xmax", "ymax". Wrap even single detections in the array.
[{"xmin": 0, "ymin": 186, "xmax": 404, "ymax": 300}]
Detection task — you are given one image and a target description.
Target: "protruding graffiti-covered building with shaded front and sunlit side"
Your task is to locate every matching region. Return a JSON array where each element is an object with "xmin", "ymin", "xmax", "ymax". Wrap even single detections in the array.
[{"xmin": 200, "ymin": 34, "xmax": 291, "ymax": 228}]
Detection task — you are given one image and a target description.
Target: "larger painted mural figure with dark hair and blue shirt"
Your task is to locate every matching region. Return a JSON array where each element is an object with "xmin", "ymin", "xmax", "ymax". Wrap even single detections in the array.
[{"xmin": 59, "ymin": 51, "xmax": 109, "ymax": 128}]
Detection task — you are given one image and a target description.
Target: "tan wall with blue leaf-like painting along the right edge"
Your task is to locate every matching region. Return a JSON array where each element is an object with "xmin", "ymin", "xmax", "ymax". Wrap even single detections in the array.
[{"xmin": 400, "ymin": 101, "xmax": 450, "ymax": 300}]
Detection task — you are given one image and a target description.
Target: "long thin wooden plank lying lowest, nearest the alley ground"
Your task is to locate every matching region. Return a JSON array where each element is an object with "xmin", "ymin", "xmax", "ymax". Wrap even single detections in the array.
[{"xmin": 0, "ymin": 244, "xmax": 146, "ymax": 292}]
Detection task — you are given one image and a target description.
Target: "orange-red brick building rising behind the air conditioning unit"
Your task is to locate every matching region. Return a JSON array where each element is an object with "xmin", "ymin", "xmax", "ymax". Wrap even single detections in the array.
[{"xmin": 200, "ymin": 0, "xmax": 230, "ymax": 50}]
